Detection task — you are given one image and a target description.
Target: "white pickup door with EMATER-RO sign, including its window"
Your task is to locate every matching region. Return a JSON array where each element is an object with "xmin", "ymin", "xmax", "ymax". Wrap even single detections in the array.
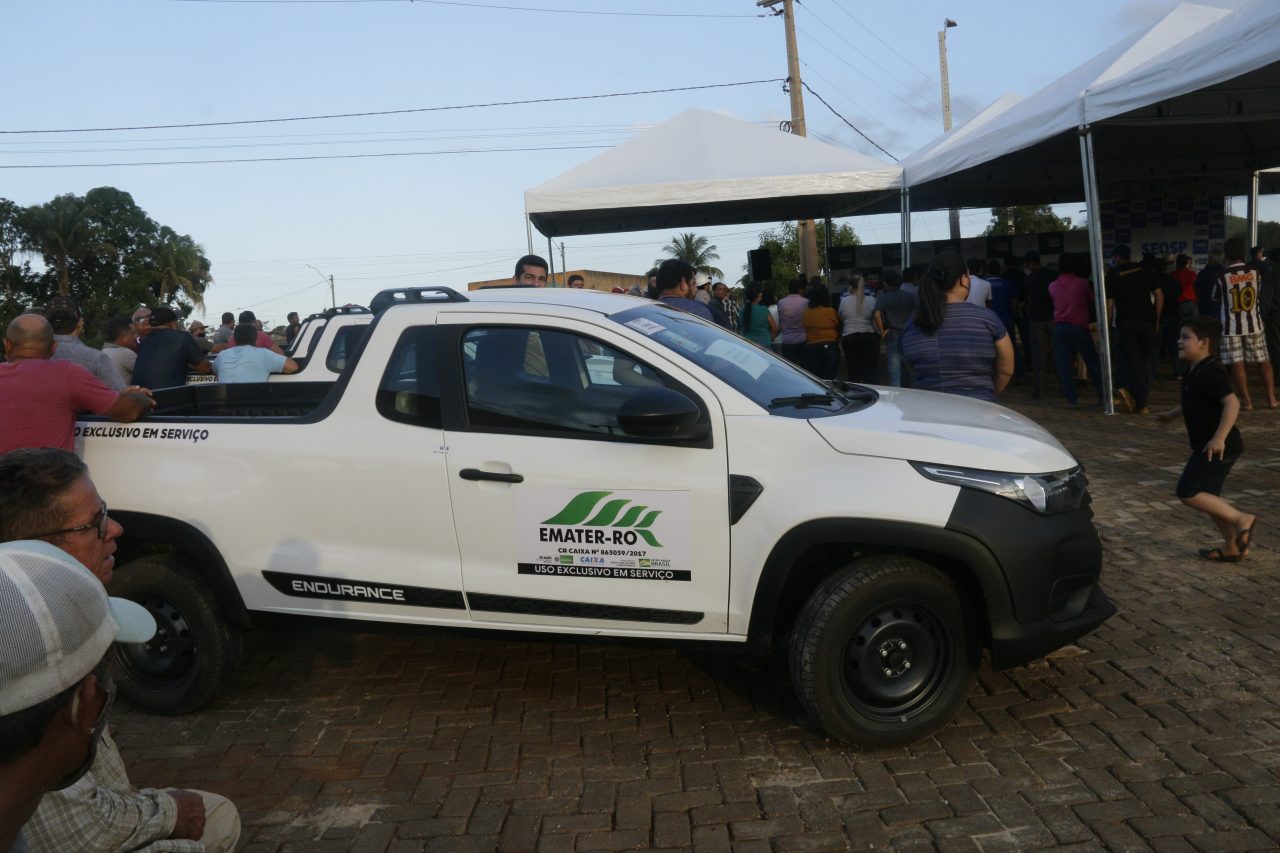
[{"xmin": 439, "ymin": 315, "xmax": 730, "ymax": 634}]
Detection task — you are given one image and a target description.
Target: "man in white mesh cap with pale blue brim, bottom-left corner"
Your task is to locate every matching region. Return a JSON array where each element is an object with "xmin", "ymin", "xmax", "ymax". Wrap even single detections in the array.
[{"xmin": 0, "ymin": 542, "xmax": 156, "ymax": 853}]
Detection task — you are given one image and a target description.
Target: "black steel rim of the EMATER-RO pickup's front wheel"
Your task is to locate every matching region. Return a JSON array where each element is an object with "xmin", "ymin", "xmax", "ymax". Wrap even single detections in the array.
[{"xmin": 841, "ymin": 603, "xmax": 955, "ymax": 721}]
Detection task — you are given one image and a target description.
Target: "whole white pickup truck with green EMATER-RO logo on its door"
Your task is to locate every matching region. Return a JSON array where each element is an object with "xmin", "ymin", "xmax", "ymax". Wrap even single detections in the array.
[{"xmin": 78, "ymin": 288, "xmax": 1115, "ymax": 745}]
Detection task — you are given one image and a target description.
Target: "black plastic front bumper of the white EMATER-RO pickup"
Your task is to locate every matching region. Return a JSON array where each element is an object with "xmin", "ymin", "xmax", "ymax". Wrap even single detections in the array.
[{"xmin": 947, "ymin": 489, "xmax": 1116, "ymax": 669}]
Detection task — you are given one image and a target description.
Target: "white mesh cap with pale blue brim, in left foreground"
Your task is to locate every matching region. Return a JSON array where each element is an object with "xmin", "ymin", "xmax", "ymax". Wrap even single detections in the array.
[{"xmin": 0, "ymin": 540, "xmax": 156, "ymax": 716}]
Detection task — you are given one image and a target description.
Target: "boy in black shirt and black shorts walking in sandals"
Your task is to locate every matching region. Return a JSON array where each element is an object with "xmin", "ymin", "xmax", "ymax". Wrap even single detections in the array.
[{"xmin": 1156, "ymin": 316, "xmax": 1258, "ymax": 562}]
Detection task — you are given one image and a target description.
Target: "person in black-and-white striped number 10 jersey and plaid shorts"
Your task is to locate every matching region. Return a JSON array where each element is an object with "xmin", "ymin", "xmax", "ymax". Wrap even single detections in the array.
[{"xmin": 1213, "ymin": 237, "xmax": 1276, "ymax": 410}]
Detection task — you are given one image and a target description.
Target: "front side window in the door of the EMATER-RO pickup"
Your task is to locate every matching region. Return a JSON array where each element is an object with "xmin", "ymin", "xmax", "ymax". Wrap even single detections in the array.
[{"xmin": 462, "ymin": 327, "xmax": 669, "ymax": 438}]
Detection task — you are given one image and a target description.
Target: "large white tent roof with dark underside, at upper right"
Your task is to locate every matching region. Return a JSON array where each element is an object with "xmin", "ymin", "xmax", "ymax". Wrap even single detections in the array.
[{"xmin": 902, "ymin": 0, "xmax": 1280, "ymax": 210}]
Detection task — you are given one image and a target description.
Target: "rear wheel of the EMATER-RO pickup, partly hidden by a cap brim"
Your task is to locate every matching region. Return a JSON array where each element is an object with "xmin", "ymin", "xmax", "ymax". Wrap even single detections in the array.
[{"xmin": 109, "ymin": 555, "xmax": 241, "ymax": 715}]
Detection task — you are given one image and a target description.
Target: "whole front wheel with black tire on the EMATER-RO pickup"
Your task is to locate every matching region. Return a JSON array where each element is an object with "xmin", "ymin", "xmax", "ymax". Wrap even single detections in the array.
[{"xmin": 791, "ymin": 557, "xmax": 982, "ymax": 748}]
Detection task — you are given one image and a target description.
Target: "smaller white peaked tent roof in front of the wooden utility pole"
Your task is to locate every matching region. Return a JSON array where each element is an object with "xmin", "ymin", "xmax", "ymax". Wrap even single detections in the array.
[{"xmin": 525, "ymin": 109, "xmax": 901, "ymax": 237}]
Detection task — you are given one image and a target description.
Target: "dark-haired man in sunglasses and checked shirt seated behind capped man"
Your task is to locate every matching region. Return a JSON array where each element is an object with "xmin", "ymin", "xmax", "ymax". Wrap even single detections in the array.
[{"xmin": 0, "ymin": 447, "xmax": 241, "ymax": 853}]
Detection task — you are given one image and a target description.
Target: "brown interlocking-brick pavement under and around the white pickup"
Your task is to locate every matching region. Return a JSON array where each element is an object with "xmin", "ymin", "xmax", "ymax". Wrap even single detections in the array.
[{"xmin": 115, "ymin": 382, "xmax": 1280, "ymax": 853}]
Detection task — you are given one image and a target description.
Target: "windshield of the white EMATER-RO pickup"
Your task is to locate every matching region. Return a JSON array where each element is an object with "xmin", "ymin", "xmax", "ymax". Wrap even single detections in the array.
[{"xmin": 609, "ymin": 302, "xmax": 876, "ymax": 418}]
